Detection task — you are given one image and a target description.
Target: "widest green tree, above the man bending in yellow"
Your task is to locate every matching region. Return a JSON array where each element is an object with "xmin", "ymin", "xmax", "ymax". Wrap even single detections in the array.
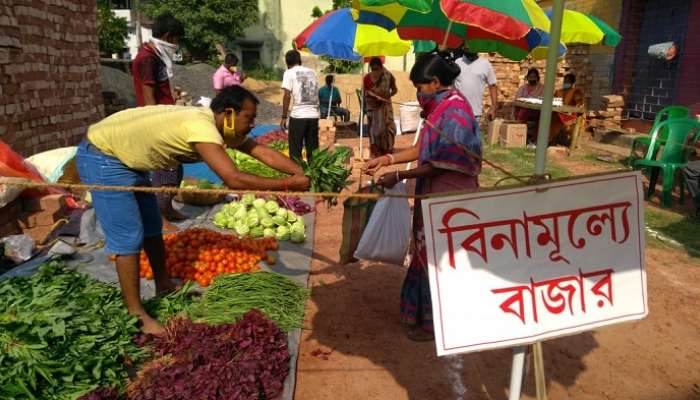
[{"xmin": 143, "ymin": 0, "xmax": 259, "ymax": 60}]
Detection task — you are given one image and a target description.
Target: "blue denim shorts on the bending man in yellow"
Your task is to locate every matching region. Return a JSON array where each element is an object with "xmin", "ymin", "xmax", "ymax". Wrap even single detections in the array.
[{"xmin": 76, "ymin": 140, "xmax": 163, "ymax": 256}]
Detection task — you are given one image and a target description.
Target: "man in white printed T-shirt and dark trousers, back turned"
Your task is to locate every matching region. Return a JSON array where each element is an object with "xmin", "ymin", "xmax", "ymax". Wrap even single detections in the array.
[{"xmin": 280, "ymin": 50, "xmax": 320, "ymax": 162}]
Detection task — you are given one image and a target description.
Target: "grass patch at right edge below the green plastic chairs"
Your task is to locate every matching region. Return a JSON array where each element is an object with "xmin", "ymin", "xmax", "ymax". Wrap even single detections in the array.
[{"xmin": 644, "ymin": 205, "xmax": 700, "ymax": 257}]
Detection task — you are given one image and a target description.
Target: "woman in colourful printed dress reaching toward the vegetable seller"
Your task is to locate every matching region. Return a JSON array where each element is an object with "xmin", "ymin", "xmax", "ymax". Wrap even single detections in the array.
[{"xmin": 364, "ymin": 54, "xmax": 481, "ymax": 341}]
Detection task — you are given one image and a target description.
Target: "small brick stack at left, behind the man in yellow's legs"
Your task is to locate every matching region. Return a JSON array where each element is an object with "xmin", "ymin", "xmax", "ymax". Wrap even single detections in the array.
[{"xmin": 16, "ymin": 194, "xmax": 66, "ymax": 244}]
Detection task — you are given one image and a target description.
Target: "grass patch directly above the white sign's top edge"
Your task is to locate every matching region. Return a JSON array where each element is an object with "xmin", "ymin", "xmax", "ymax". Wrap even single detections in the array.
[{"xmin": 479, "ymin": 145, "xmax": 571, "ymax": 186}]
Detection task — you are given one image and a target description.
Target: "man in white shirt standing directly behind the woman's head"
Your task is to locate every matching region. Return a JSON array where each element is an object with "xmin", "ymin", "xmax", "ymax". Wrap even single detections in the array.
[{"xmin": 455, "ymin": 49, "xmax": 498, "ymax": 121}]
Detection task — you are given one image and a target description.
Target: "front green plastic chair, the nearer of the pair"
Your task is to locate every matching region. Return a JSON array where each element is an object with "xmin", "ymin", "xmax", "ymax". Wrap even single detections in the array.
[{"xmin": 632, "ymin": 118, "xmax": 700, "ymax": 207}]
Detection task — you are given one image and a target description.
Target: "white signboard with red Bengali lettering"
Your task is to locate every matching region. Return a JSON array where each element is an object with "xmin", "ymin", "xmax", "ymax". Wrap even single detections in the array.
[{"xmin": 423, "ymin": 172, "xmax": 648, "ymax": 355}]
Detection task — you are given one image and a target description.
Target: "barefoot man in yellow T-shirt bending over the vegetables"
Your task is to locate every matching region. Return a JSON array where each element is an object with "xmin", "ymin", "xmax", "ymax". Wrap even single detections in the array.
[{"xmin": 76, "ymin": 86, "xmax": 309, "ymax": 334}]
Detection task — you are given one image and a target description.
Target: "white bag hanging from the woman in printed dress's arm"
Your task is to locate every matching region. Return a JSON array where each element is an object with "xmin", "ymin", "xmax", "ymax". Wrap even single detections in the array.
[{"xmin": 355, "ymin": 183, "xmax": 411, "ymax": 265}]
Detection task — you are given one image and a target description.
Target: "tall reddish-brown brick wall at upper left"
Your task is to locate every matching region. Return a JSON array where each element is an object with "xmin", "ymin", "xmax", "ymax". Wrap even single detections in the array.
[{"xmin": 0, "ymin": 0, "xmax": 103, "ymax": 156}]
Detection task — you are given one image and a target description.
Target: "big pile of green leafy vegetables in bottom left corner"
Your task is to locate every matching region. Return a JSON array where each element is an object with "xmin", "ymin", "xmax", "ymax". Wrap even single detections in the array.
[{"xmin": 0, "ymin": 262, "xmax": 145, "ymax": 400}]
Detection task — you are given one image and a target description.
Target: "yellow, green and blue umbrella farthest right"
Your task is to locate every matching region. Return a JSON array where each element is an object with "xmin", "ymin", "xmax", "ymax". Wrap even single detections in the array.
[{"xmin": 546, "ymin": 9, "xmax": 622, "ymax": 47}]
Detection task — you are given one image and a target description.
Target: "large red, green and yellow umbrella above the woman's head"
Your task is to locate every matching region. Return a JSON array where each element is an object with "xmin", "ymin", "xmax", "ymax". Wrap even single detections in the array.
[{"xmin": 353, "ymin": 0, "xmax": 549, "ymax": 61}]
